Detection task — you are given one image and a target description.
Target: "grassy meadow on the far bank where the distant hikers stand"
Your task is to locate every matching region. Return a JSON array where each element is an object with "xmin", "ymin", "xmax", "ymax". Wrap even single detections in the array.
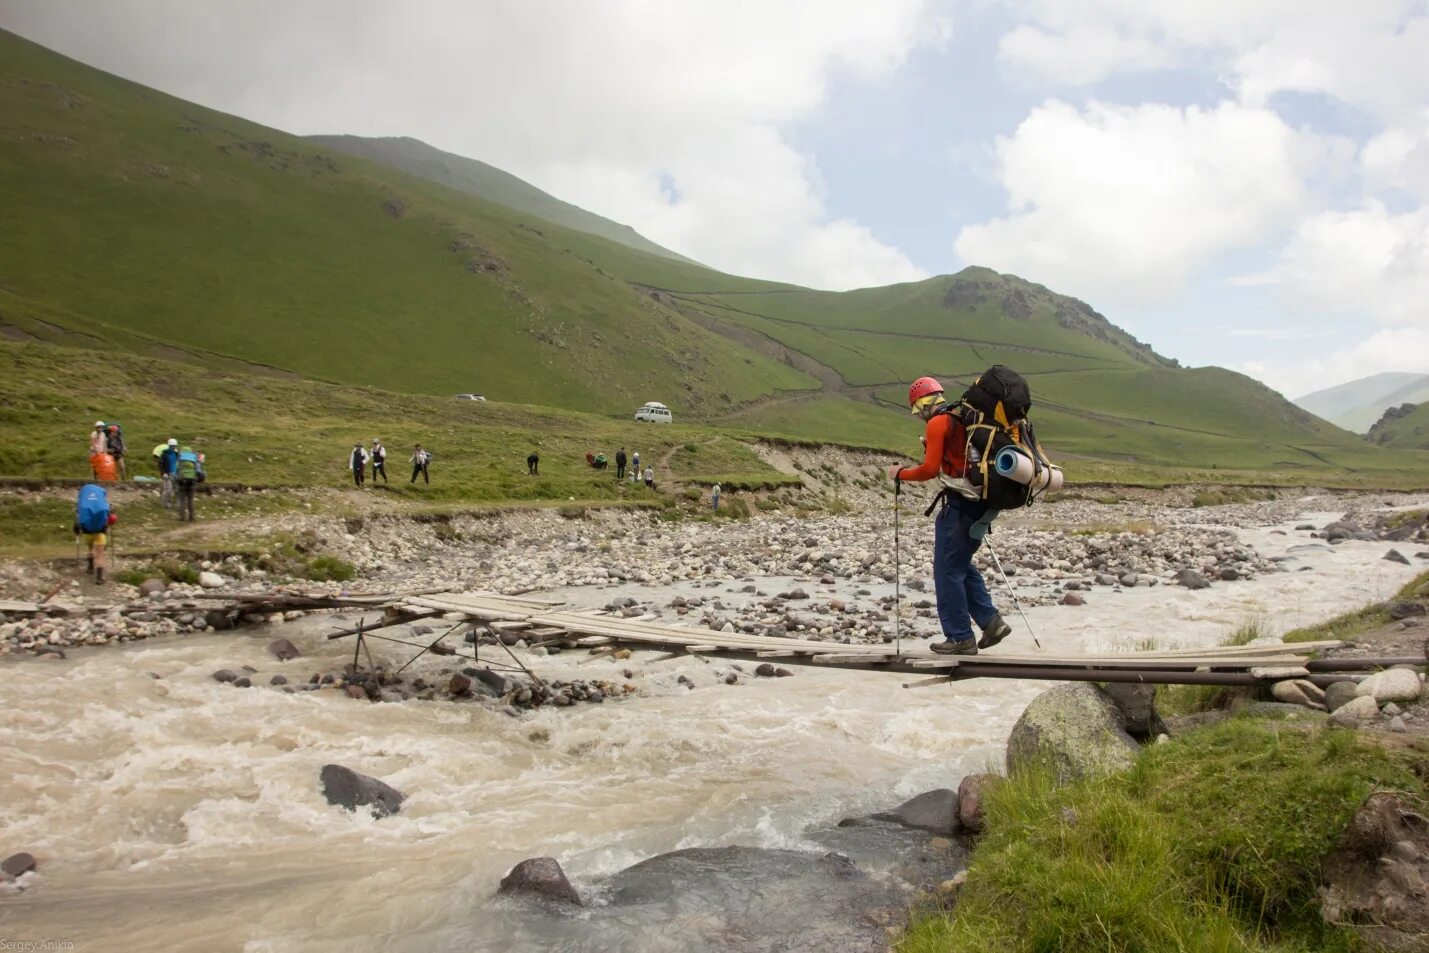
[{"xmin": 0, "ymin": 341, "xmax": 790, "ymax": 491}]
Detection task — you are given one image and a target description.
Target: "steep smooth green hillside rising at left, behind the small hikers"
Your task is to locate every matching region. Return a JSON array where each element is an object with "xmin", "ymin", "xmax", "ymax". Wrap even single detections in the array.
[{"xmin": 0, "ymin": 33, "xmax": 813, "ymax": 410}]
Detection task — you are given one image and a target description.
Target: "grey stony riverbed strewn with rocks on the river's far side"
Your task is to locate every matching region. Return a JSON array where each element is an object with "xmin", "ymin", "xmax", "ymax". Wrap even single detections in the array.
[{"xmin": 0, "ymin": 492, "xmax": 1429, "ymax": 653}]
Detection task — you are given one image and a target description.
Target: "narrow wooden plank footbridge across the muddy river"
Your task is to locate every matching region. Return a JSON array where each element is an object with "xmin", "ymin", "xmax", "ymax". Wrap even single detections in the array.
[{"xmin": 329, "ymin": 592, "xmax": 1425, "ymax": 686}]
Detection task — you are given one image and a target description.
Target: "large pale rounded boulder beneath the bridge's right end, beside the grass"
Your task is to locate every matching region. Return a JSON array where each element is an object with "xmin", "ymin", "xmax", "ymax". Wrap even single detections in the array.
[{"xmin": 1007, "ymin": 683, "xmax": 1140, "ymax": 782}]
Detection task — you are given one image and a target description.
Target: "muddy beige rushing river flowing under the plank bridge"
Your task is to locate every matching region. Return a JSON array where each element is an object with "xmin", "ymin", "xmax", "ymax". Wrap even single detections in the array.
[{"xmin": 0, "ymin": 504, "xmax": 1415, "ymax": 952}]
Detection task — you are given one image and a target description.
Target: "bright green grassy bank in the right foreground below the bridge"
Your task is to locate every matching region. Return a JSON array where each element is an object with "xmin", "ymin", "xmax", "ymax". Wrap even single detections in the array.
[{"xmin": 897, "ymin": 719, "xmax": 1429, "ymax": 953}]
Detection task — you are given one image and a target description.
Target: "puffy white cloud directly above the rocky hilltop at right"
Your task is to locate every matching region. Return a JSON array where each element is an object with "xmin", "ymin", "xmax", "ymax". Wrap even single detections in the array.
[{"xmin": 955, "ymin": 101, "xmax": 1323, "ymax": 306}]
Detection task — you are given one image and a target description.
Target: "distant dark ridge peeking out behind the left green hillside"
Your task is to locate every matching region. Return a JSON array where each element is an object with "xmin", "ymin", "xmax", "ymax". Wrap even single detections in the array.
[{"xmin": 306, "ymin": 136, "xmax": 696, "ymax": 264}]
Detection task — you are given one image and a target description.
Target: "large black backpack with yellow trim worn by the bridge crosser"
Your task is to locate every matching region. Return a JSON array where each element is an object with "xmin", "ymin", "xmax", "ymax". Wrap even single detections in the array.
[{"xmin": 953, "ymin": 364, "xmax": 1060, "ymax": 510}]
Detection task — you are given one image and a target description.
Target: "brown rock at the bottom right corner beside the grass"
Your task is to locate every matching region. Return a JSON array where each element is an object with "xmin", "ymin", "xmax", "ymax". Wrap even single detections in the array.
[{"xmin": 1320, "ymin": 792, "xmax": 1429, "ymax": 950}]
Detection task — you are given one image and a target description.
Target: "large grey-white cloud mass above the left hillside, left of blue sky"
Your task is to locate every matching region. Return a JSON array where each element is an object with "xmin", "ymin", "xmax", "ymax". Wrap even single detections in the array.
[{"xmin": 0, "ymin": 0, "xmax": 947, "ymax": 287}]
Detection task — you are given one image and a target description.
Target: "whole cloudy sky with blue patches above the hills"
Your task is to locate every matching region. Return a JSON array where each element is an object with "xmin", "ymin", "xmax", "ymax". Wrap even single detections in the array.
[{"xmin": 0, "ymin": 0, "xmax": 1429, "ymax": 397}]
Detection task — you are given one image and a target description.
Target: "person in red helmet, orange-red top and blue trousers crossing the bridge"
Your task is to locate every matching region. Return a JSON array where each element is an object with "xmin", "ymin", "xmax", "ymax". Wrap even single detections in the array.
[{"xmin": 889, "ymin": 377, "xmax": 1012, "ymax": 656}]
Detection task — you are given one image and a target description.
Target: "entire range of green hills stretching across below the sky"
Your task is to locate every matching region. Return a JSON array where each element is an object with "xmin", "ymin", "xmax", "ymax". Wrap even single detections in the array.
[{"xmin": 0, "ymin": 31, "xmax": 1423, "ymax": 483}]
